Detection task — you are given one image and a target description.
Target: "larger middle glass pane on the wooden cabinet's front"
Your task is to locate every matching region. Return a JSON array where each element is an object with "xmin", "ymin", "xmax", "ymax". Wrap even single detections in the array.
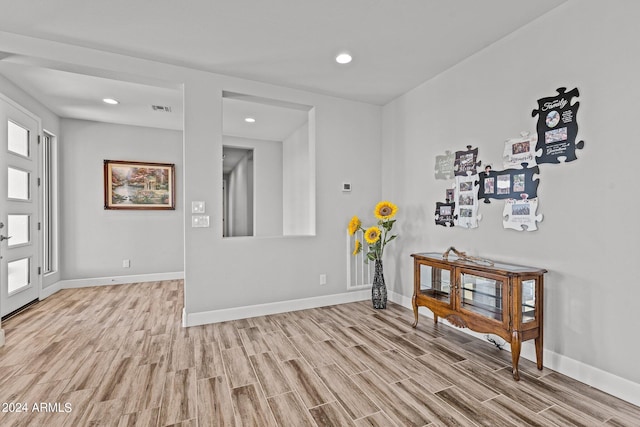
[{"xmin": 460, "ymin": 272, "xmax": 504, "ymax": 321}]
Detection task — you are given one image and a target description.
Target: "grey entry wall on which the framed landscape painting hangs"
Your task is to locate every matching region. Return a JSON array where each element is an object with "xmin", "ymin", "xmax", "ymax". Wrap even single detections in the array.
[{"xmin": 60, "ymin": 119, "xmax": 184, "ymax": 280}]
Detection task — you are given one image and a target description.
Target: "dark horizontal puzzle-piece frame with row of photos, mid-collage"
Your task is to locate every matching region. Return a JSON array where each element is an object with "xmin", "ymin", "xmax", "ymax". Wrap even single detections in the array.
[{"xmin": 478, "ymin": 165, "xmax": 540, "ymax": 203}]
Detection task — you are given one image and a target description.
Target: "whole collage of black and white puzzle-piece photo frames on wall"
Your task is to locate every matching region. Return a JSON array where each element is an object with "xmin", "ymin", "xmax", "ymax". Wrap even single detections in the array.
[{"xmin": 435, "ymin": 87, "xmax": 584, "ymax": 231}]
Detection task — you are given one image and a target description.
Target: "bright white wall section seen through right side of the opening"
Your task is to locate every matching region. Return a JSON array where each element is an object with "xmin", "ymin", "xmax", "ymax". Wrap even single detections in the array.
[{"xmin": 282, "ymin": 123, "xmax": 314, "ymax": 236}]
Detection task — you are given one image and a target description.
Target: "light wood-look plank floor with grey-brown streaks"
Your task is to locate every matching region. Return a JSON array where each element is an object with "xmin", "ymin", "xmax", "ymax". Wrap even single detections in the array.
[{"xmin": 0, "ymin": 281, "xmax": 640, "ymax": 427}]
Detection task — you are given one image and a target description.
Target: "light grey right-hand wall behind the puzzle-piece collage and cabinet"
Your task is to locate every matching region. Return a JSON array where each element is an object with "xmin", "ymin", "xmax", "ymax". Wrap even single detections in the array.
[{"xmin": 383, "ymin": 0, "xmax": 640, "ymax": 392}]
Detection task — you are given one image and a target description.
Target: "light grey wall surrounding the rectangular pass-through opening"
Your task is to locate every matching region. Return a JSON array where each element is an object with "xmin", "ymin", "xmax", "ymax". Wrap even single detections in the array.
[{"xmin": 184, "ymin": 73, "xmax": 382, "ymax": 315}]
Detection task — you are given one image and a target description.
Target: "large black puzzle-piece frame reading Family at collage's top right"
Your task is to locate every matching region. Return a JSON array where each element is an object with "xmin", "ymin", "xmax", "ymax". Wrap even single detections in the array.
[{"xmin": 531, "ymin": 87, "xmax": 584, "ymax": 164}]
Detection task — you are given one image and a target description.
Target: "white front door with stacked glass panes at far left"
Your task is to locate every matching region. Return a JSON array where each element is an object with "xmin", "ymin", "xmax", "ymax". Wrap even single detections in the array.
[{"xmin": 0, "ymin": 96, "xmax": 40, "ymax": 316}]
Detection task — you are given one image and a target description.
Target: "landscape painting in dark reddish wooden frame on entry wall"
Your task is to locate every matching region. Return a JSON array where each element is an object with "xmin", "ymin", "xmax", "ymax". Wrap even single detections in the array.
[{"xmin": 104, "ymin": 160, "xmax": 176, "ymax": 210}]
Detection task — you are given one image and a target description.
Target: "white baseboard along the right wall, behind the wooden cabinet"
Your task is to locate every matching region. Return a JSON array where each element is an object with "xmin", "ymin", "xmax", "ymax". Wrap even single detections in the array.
[{"xmin": 389, "ymin": 291, "xmax": 640, "ymax": 406}]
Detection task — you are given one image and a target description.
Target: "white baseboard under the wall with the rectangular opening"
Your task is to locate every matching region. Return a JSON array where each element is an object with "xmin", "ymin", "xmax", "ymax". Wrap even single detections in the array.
[{"xmin": 182, "ymin": 290, "xmax": 371, "ymax": 327}]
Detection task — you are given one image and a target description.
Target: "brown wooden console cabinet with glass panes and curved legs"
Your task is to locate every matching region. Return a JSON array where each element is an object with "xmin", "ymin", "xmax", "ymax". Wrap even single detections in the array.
[{"xmin": 411, "ymin": 253, "xmax": 547, "ymax": 381}]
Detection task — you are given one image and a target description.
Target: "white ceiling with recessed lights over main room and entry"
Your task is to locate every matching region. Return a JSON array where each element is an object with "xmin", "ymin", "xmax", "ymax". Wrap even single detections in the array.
[{"xmin": 0, "ymin": 0, "xmax": 566, "ymax": 134}]
